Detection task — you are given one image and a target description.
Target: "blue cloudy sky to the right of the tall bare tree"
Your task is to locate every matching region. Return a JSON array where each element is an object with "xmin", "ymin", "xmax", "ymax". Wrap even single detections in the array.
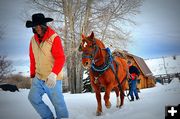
[{"xmin": 129, "ymin": 0, "xmax": 180, "ymax": 58}]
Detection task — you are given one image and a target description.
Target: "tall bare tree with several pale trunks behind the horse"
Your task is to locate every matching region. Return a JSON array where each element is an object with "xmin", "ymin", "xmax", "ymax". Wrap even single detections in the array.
[{"xmin": 23, "ymin": 0, "xmax": 143, "ymax": 93}]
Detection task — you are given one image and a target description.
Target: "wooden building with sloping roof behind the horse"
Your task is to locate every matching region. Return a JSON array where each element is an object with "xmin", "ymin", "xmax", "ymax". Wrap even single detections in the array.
[{"xmin": 115, "ymin": 50, "xmax": 155, "ymax": 89}]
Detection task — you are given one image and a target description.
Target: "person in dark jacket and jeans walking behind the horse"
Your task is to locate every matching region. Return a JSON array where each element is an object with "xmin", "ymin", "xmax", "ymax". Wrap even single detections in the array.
[{"xmin": 127, "ymin": 60, "xmax": 140, "ymax": 101}]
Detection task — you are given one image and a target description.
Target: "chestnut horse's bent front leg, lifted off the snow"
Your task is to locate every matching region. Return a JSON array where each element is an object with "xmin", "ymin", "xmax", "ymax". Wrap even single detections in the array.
[{"xmin": 104, "ymin": 85, "xmax": 113, "ymax": 108}]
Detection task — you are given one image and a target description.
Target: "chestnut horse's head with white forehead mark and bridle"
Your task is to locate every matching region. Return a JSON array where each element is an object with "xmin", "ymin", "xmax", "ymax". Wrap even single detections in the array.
[{"xmin": 79, "ymin": 32, "xmax": 104, "ymax": 69}]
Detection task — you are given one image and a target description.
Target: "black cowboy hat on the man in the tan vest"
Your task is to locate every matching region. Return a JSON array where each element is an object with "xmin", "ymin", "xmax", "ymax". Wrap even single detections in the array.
[{"xmin": 26, "ymin": 13, "xmax": 53, "ymax": 28}]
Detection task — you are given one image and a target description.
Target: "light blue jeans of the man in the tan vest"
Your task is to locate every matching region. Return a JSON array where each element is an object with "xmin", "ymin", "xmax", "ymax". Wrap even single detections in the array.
[{"xmin": 28, "ymin": 77, "xmax": 69, "ymax": 119}]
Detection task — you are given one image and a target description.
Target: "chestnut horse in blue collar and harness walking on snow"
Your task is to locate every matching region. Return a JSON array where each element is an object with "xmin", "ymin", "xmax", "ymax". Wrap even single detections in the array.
[{"xmin": 79, "ymin": 32, "xmax": 128, "ymax": 116}]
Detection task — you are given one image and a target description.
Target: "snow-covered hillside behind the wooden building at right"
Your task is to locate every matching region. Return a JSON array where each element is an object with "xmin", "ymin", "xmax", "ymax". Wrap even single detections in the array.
[{"xmin": 145, "ymin": 55, "xmax": 180, "ymax": 75}]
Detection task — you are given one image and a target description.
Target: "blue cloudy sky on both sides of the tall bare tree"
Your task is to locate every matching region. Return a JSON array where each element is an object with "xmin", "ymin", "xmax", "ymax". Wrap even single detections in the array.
[{"xmin": 0, "ymin": 0, "xmax": 180, "ymax": 73}]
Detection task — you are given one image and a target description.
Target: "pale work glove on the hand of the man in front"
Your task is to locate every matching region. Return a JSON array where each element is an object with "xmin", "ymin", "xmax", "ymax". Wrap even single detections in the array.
[{"xmin": 45, "ymin": 72, "xmax": 57, "ymax": 88}]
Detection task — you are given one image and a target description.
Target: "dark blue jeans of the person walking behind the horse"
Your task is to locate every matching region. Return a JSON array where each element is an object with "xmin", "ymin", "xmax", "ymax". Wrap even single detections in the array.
[{"xmin": 130, "ymin": 79, "xmax": 139, "ymax": 99}]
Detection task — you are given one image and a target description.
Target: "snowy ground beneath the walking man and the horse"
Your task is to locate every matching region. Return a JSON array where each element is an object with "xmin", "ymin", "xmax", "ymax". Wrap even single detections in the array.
[{"xmin": 0, "ymin": 79, "xmax": 180, "ymax": 119}]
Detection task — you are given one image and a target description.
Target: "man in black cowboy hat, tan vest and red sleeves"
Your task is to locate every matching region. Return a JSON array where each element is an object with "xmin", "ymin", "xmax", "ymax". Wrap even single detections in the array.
[{"xmin": 26, "ymin": 13, "xmax": 69, "ymax": 119}]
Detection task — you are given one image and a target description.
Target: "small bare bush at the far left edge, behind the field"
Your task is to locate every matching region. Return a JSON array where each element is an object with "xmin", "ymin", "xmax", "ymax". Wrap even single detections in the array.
[{"xmin": 0, "ymin": 56, "xmax": 13, "ymax": 82}]
